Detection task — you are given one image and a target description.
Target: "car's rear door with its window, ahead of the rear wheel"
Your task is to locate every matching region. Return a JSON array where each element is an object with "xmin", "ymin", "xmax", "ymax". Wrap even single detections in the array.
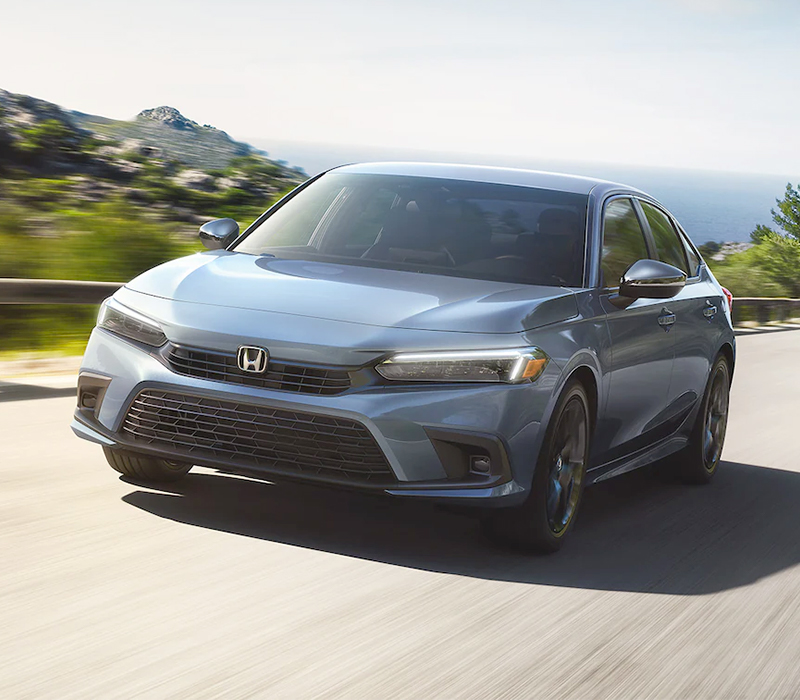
[{"xmin": 639, "ymin": 200, "xmax": 725, "ymax": 428}]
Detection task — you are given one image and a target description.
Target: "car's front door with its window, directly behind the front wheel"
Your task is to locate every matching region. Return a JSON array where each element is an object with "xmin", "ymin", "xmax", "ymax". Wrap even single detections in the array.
[{"xmin": 592, "ymin": 196, "xmax": 674, "ymax": 466}]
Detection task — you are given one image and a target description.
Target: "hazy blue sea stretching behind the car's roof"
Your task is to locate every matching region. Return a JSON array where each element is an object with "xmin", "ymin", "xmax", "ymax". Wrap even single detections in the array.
[{"xmin": 258, "ymin": 138, "xmax": 800, "ymax": 245}]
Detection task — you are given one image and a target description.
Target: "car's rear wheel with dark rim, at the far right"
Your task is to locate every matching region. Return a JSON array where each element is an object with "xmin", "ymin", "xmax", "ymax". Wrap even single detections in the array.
[{"xmin": 671, "ymin": 355, "xmax": 731, "ymax": 484}]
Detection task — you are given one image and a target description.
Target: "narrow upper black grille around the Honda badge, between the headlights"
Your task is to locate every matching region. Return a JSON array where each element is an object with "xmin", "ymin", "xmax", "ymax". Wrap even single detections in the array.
[{"xmin": 165, "ymin": 345, "xmax": 350, "ymax": 395}]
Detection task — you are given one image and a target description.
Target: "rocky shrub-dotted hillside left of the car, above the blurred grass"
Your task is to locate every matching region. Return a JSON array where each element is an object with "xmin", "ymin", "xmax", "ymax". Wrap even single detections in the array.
[{"xmin": 0, "ymin": 90, "xmax": 306, "ymax": 223}]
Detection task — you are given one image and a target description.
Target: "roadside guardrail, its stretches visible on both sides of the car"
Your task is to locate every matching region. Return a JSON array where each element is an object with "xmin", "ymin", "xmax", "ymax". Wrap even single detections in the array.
[{"xmin": 0, "ymin": 278, "xmax": 800, "ymax": 325}]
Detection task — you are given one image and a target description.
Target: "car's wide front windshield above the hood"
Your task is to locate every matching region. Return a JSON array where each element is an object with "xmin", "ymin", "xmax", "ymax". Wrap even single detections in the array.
[{"xmin": 235, "ymin": 171, "xmax": 588, "ymax": 287}]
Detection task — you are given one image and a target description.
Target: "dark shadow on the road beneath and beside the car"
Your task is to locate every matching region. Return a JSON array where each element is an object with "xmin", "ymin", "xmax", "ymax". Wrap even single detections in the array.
[{"xmin": 123, "ymin": 462, "xmax": 800, "ymax": 595}]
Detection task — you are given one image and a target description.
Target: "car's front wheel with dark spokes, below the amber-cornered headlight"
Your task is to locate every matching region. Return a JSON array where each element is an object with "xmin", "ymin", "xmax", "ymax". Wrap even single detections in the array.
[{"xmin": 482, "ymin": 380, "xmax": 592, "ymax": 554}]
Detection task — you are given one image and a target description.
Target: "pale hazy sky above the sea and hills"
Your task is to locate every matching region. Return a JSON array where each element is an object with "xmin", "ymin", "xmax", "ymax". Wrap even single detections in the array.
[{"xmin": 0, "ymin": 0, "xmax": 800, "ymax": 176}]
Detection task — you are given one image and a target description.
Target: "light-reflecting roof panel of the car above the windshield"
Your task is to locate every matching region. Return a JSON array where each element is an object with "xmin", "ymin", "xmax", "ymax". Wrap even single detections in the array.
[{"xmin": 336, "ymin": 162, "xmax": 638, "ymax": 194}]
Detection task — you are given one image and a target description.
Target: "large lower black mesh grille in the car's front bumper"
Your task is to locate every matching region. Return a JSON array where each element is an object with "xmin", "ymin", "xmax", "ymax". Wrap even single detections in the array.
[{"xmin": 122, "ymin": 389, "xmax": 394, "ymax": 484}]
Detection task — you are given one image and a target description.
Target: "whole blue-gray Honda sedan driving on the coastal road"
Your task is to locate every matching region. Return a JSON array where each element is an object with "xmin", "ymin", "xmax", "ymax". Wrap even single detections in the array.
[{"xmin": 72, "ymin": 163, "xmax": 735, "ymax": 551}]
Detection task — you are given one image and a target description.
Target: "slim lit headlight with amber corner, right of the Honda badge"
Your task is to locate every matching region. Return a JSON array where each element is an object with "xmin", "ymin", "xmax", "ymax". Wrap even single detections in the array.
[{"xmin": 375, "ymin": 348, "xmax": 548, "ymax": 384}]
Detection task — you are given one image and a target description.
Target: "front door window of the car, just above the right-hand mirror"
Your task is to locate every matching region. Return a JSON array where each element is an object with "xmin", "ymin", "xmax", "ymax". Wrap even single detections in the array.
[{"xmin": 601, "ymin": 199, "xmax": 648, "ymax": 287}]
